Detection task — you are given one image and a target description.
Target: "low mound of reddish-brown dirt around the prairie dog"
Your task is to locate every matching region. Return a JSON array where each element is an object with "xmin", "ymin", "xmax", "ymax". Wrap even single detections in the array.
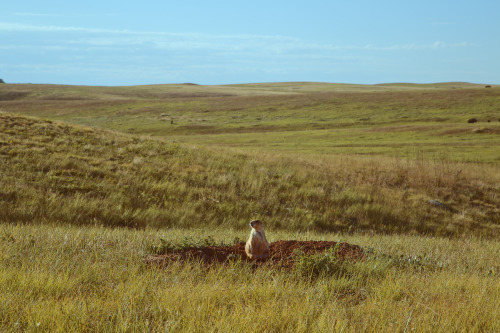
[{"xmin": 145, "ymin": 240, "xmax": 364, "ymax": 268}]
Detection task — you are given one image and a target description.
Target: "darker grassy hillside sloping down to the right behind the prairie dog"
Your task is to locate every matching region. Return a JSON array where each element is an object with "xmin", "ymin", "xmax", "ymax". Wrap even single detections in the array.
[{"xmin": 0, "ymin": 113, "xmax": 500, "ymax": 237}]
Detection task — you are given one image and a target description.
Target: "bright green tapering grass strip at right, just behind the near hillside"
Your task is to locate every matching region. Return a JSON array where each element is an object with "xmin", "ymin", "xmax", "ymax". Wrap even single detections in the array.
[{"xmin": 172, "ymin": 123, "xmax": 500, "ymax": 163}]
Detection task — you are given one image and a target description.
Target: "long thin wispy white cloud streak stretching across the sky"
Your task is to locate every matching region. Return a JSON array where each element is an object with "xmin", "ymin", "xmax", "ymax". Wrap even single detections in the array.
[{"xmin": 0, "ymin": 22, "xmax": 471, "ymax": 54}]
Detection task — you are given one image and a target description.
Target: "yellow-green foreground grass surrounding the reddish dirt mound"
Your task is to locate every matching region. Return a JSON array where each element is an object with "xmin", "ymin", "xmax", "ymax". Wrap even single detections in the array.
[{"xmin": 0, "ymin": 224, "xmax": 500, "ymax": 332}]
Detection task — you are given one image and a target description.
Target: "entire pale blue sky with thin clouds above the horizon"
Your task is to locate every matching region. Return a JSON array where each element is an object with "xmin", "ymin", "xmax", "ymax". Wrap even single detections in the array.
[{"xmin": 0, "ymin": 0, "xmax": 500, "ymax": 86}]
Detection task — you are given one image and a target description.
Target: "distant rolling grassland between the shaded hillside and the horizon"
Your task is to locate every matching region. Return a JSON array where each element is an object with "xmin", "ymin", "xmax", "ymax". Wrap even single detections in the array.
[{"xmin": 0, "ymin": 83, "xmax": 500, "ymax": 164}]
